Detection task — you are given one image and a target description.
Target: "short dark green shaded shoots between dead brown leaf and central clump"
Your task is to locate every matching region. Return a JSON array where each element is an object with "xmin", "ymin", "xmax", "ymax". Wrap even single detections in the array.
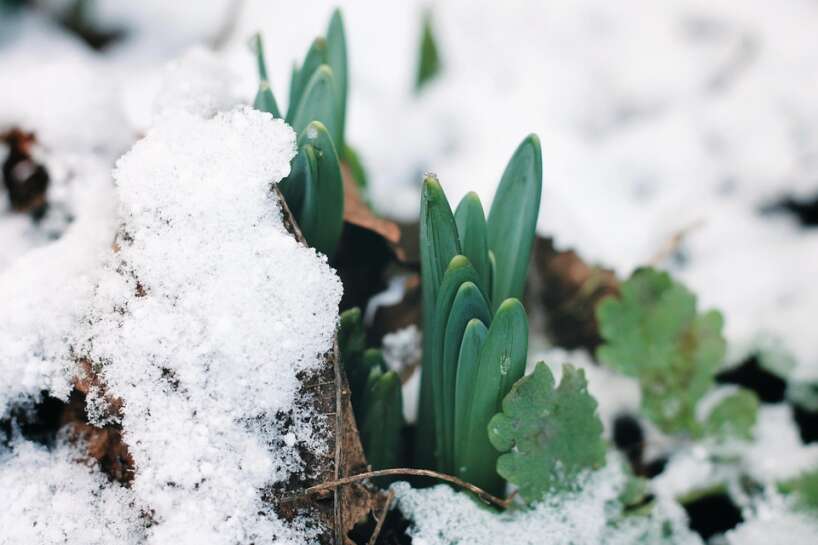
[{"xmin": 338, "ymin": 308, "xmax": 404, "ymax": 469}]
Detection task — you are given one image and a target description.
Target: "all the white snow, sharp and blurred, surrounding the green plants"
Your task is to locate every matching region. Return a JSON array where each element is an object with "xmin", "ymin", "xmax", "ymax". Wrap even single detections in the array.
[{"xmin": 0, "ymin": 0, "xmax": 818, "ymax": 545}]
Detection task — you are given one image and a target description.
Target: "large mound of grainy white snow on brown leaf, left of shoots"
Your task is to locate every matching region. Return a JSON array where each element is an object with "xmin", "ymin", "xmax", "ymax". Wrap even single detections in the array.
[{"xmin": 70, "ymin": 104, "xmax": 341, "ymax": 544}]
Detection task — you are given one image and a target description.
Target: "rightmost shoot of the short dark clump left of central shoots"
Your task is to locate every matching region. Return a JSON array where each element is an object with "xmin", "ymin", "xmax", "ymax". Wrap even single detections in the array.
[{"xmin": 360, "ymin": 367, "xmax": 403, "ymax": 470}]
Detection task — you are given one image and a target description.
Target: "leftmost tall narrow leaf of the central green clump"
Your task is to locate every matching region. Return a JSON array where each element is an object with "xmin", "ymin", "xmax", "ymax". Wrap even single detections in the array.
[{"xmin": 415, "ymin": 175, "xmax": 460, "ymax": 468}]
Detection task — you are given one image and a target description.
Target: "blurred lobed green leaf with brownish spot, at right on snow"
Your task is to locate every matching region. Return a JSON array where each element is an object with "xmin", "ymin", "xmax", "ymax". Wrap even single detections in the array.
[{"xmin": 597, "ymin": 269, "xmax": 726, "ymax": 435}]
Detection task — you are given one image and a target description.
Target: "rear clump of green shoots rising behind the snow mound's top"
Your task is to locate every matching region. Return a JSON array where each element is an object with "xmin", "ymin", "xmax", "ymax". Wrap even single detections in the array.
[{"xmin": 253, "ymin": 10, "xmax": 348, "ymax": 257}]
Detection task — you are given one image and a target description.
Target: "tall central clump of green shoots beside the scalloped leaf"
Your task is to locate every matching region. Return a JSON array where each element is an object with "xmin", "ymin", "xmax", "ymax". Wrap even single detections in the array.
[{"xmin": 416, "ymin": 135, "xmax": 542, "ymax": 493}]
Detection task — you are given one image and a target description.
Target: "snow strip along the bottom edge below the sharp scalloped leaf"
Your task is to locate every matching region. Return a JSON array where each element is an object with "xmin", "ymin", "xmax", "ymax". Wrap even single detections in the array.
[{"xmin": 392, "ymin": 455, "xmax": 702, "ymax": 545}]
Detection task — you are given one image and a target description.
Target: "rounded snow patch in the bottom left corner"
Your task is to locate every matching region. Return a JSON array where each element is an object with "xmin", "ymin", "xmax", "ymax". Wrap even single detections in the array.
[{"xmin": 0, "ymin": 439, "xmax": 144, "ymax": 545}]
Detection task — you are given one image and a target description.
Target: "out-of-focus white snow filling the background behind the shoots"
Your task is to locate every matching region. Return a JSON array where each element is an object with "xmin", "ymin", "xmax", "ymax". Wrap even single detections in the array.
[{"xmin": 0, "ymin": 0, "xmax": 818, "ymax": 386}]
